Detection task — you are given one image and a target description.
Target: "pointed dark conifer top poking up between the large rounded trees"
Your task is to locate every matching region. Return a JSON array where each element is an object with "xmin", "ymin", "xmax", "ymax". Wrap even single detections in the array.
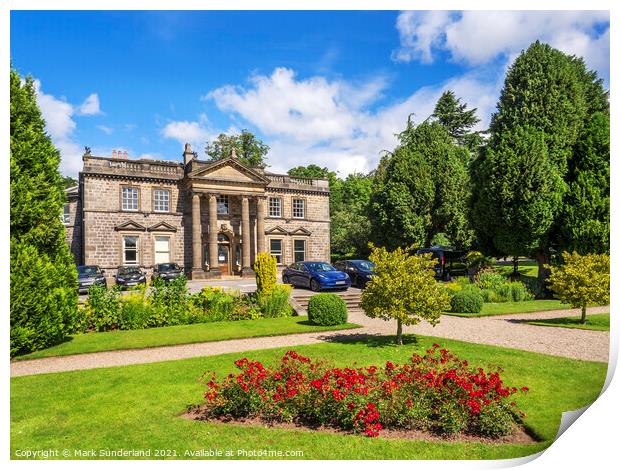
[{"xmin": 432, "ymin": 90, "xmax": 482, "ymax": 150}]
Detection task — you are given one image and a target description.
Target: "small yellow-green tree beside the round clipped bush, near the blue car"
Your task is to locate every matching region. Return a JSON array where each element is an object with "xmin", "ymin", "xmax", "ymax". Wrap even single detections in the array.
[{"xmin": 361, "ymin": 245, "xmax": 450, "ymax": 345}]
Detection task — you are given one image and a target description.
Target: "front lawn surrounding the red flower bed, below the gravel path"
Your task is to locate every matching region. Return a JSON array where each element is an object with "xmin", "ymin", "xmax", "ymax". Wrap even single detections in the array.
[{"xmin": 10, "ymin": 336, "xmax": 607, "ymax": 459}]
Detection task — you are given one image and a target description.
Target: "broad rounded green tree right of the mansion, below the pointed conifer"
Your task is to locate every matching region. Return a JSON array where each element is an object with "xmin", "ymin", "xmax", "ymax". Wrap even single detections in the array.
[{"xmin": 370, "ymin": 122, "xmax": 472, "ymax": 248}]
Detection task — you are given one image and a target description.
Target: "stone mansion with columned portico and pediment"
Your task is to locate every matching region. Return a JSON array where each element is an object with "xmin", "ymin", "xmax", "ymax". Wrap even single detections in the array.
[{"xmin": 62, "ymin": 144, "xmax": 330, "ymax": 279}]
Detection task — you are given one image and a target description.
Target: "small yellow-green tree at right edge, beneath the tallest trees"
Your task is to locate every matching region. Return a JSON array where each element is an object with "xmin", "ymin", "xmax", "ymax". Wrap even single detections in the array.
[{"xmin": 548, "ymin": 252, "xmax": 609, "ymax": 324}]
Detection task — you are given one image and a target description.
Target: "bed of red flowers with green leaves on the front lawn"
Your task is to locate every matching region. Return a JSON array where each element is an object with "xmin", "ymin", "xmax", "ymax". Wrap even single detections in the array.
[{"xmin": 201, "ymin": 344, "xmax": 527, "ymax": 438}]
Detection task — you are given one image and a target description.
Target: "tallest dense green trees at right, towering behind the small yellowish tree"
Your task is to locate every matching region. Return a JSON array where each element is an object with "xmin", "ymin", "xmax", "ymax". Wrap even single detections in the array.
[{"xmin": 472, "ymin": 42, "xmax": 609, "ymax": 282}]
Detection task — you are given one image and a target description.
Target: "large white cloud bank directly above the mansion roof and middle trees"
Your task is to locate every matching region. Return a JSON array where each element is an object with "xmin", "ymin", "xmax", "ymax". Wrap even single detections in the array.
[{"xmin": 201, "ymin": 68, "xmax": 500, "ymax": 176}]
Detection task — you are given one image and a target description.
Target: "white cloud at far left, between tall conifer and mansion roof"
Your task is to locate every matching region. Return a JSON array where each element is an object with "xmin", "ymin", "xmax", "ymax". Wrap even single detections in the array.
[{"xmin": 34, "ymin": 80, "xmax": 99, "ymax": 176}]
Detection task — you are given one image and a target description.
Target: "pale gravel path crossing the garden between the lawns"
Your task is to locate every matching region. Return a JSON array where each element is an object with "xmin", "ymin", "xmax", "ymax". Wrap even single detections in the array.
[{"xmin": 11, "ymin": 307, "xmax": 609, "ymax": 377}]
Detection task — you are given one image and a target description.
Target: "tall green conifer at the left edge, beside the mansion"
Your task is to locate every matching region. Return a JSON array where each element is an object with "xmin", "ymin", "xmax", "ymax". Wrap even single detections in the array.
[{"xmin": 9, "ymin": 68, "xmax": 77, "ymax": 355}]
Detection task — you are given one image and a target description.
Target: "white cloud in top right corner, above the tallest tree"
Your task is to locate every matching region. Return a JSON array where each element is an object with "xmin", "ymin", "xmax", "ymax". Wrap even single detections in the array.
[{"xmin": 393, "ymin": 11, "xmax": 609, "ymax": 76}]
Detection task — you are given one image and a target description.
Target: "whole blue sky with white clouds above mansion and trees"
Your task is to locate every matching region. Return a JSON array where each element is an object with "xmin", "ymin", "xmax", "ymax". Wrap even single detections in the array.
[{"xmin": 11, "ymin": 11, "xmax": 609, "ymax": 175}]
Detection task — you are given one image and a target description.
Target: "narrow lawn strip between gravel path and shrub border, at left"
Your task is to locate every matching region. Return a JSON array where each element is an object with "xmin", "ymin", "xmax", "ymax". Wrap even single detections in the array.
[{"xmin": 15, "ymin": 317, "xmax": 360, "ymax": 360}]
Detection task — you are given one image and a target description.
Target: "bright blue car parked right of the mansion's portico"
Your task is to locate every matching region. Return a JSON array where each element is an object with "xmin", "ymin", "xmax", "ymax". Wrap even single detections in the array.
[{"xmin": 282, "ymin": 261, "xmax": 351, "ymax": 292}]
